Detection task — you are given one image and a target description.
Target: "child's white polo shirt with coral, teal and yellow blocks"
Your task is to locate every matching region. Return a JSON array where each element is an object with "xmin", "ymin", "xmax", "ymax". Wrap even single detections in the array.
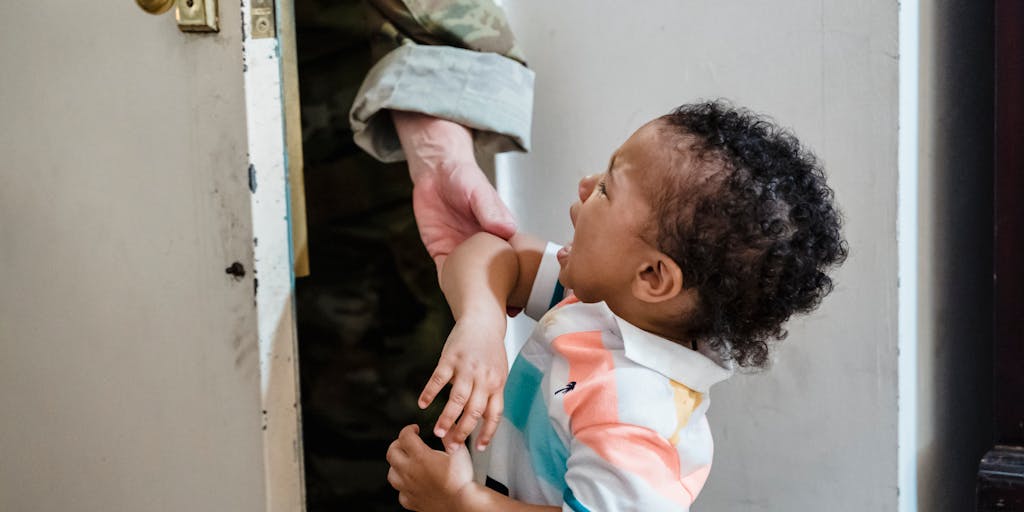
[{"xmin": 486, "ymin": 244, "xmax": 731, "ymax": 512}]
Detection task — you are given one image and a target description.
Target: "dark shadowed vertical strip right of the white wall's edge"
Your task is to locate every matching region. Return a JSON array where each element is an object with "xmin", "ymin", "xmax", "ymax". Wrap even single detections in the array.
[{"xmin": 918, "ymin": 0, "xmax": 994, "ymax": 512}]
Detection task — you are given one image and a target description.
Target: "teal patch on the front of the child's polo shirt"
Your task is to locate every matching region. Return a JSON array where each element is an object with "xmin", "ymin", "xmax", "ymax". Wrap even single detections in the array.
[{"xmin": 505, "ymin": 355, "xmax": 569, "ymax": 492}]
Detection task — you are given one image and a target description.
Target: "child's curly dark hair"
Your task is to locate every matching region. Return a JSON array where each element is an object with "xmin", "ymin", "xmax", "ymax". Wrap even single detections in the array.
[{"xmin": 653, "ymin": 100, "xmax": 847, "ymax": 368}]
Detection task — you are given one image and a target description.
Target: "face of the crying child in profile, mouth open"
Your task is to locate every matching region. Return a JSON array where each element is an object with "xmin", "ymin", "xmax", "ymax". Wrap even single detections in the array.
[{"xmin": 558, "ymin": 122, "xmax": 670, "ymax": 302}]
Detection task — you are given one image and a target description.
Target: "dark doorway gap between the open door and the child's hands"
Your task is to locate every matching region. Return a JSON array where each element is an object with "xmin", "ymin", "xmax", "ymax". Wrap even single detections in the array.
[{"xmin": 295, "ymin": 0, "xmax": 452, "ymax": 512}]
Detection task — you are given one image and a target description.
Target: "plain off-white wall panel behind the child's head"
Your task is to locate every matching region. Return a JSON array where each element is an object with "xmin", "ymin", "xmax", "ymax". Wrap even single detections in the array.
[{"xmin": 498, "ymin": 0, "xmax": 897, "ymax": 512}]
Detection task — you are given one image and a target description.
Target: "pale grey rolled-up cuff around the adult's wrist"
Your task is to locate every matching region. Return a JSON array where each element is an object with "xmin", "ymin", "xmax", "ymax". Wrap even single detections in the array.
[{"xmin": 349, "ymin": 44, "xmax": 534, "ymax": 162}]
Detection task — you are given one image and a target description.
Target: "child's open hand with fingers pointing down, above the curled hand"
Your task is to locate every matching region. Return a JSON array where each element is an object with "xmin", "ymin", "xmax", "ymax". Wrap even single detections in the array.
[{"xmin": 419, "ymin": 313, "xmax": 508, "ymax": 452}]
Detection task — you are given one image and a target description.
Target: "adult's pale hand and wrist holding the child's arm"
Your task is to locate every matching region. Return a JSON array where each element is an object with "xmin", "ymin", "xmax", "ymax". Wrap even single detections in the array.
[{"xmin": 391, "ymin": 111, "xmax": 516, "ymax": 268}]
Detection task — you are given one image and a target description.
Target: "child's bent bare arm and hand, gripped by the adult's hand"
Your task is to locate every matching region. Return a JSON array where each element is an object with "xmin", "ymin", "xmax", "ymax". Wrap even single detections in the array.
[{"xmin": 419, "ymin": 232, "xmax": 544, "ymax": 450}]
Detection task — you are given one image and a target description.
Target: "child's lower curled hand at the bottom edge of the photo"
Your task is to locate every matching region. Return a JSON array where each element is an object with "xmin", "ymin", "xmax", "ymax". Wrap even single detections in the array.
[{"xmin": 387, "ymin": 425, "xmax": 473, "ymax": 512}]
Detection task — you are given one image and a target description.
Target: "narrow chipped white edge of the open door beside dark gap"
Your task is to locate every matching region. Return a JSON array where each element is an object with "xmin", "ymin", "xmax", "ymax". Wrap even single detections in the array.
[{"xmin": 242, "ymin": 0, "xmax": 305, "ymax": 512}]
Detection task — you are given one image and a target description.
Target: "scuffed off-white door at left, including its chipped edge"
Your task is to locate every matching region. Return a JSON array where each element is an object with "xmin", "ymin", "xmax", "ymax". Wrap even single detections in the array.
[{"xmin": 0, "ymin": 0, "xmax": 302, "ymax": 512}]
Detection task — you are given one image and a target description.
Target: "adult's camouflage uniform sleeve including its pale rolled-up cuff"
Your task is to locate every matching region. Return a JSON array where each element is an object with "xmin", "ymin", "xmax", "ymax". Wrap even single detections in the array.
[{"xmin": 349, "ymin": 0, "xmax": 534, "ymax": 162}]
